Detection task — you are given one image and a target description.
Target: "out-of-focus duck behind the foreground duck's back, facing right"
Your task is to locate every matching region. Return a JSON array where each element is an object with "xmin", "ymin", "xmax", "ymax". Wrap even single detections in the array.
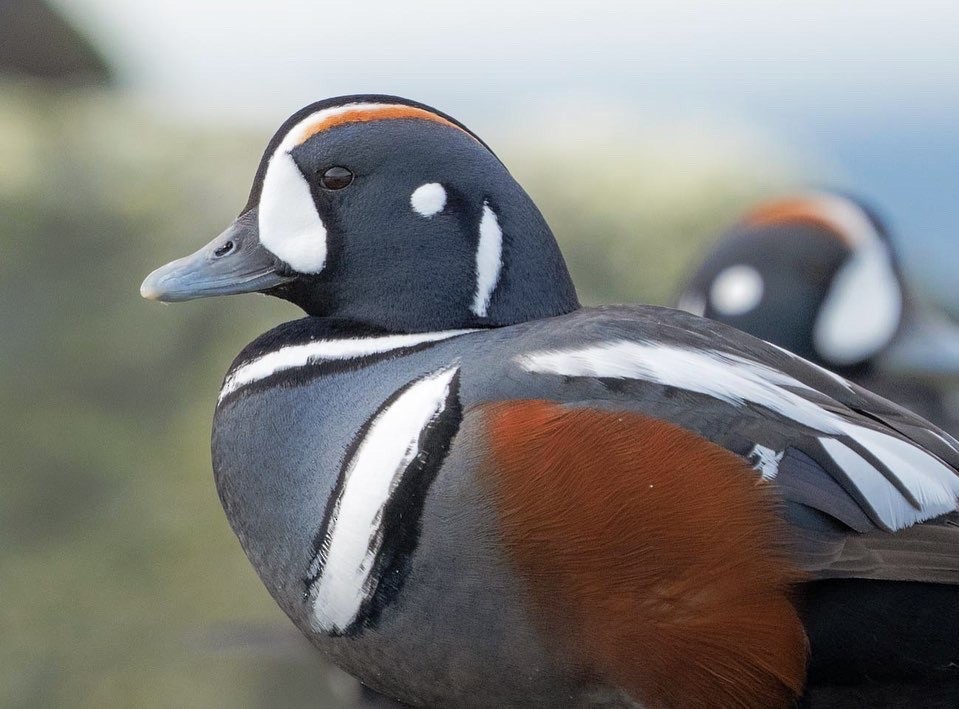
[{"xmin": 678, "ymin": 192, "xmax": 959, "ymax": 433}]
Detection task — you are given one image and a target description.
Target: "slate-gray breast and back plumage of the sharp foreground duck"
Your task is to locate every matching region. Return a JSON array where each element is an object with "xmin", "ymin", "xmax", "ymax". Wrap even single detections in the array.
[{"xmin": 213, "ymin": 306, "xmax": 959, "ymax": 706}]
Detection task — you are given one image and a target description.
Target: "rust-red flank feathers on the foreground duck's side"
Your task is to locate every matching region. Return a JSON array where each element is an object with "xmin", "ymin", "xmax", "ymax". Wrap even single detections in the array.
[{"xmin": 483, "ymin": 401, "xmax": 807, "ymax": 709}]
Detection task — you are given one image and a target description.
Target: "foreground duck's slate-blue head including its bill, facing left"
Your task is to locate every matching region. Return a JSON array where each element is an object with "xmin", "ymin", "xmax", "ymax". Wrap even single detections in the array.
[{"xmin": 141, "ymin": 95, "xmax": 579, "ymax": 332}]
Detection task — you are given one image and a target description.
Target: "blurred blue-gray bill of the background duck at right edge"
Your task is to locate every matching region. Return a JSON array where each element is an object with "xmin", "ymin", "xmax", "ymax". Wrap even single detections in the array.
[{"xmin": 879, "ymin": 311, "xmax": 959, "ymax": 382}]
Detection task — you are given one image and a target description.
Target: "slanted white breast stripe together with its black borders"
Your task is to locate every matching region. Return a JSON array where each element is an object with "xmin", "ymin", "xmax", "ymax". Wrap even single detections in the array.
[{"xmin": 306, "ymin": 366, "xmax": 462, "ymax": 635}]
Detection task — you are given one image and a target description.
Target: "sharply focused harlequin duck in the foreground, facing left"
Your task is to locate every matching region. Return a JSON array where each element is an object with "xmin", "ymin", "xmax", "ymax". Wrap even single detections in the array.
[{"xmin": 141, "ymin": 96, "xmax": 959, "ymax": 707}]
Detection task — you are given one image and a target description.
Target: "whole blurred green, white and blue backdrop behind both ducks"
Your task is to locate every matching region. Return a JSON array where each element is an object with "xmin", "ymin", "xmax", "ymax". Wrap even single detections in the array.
[{"xmin": 0, "ymin": 0, "xmax": 959, "ymax": 707}]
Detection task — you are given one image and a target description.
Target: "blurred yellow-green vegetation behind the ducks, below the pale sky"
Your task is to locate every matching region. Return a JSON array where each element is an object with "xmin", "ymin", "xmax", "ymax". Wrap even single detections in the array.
[{"xmin": 0, "ymin": 84, "xmax": 788, "ymax": 708}]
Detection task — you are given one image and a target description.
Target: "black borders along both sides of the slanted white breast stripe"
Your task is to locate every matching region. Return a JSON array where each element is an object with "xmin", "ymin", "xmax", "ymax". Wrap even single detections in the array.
[{"xmin": 304, "ymin": 371, "xmax": 463, "ymax": 636}]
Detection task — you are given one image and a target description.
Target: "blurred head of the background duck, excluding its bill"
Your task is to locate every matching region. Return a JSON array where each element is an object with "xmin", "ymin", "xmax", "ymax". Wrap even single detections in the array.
[{"xmin": 679, "ymin": 193, "xmax": 906, "ymax": 373}]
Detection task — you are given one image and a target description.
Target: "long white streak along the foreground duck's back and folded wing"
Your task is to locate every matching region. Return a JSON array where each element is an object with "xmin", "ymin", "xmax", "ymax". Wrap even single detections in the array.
[{"xmin": 517, "ymin": 340, "xmax": 959, "ymax": 529}]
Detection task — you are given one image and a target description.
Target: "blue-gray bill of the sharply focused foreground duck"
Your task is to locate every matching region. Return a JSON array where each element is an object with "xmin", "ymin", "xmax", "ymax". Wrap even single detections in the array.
[{"xmin": 140, "ymin": 210, "xmax": 290, "ymax": 303}]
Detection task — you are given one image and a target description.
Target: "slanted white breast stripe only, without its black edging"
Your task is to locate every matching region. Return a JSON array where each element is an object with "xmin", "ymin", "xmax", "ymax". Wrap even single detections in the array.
[{"xmin": 313, "ymin": 367, "xmax": 458, "ymax": 632}]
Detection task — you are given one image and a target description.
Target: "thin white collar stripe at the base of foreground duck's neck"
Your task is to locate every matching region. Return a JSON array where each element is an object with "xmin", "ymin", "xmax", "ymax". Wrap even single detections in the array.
[{"xmin": 220, "ymin": 330, "xmax": 473, "ymax": 401}]
